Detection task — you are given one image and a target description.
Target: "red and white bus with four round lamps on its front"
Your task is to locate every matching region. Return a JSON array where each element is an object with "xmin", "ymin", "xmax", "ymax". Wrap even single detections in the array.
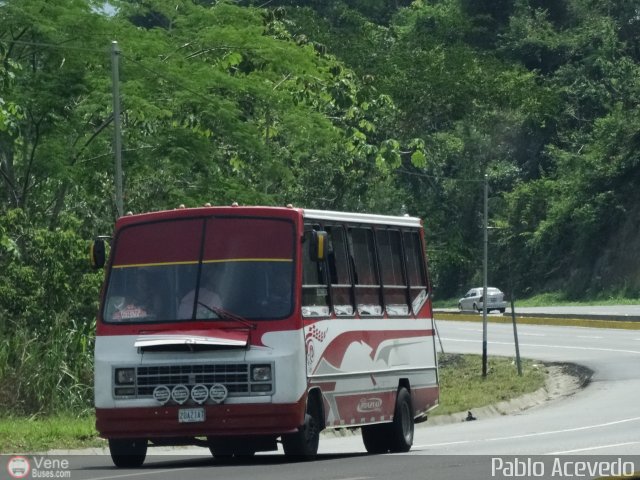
[{"xmin": 94, "ymin": 205, "xmax": 439, "ymax": 467}]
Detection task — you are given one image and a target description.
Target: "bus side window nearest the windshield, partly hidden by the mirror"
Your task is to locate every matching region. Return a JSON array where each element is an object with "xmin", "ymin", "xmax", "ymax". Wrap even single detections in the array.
[{"xmin": 302, "ymin": 230, "xmax": 329, "ymax": 317}]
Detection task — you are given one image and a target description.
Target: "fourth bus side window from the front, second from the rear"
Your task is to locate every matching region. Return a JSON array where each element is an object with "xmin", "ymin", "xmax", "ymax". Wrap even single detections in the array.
[{"xmin": 376, "ymin": 230, "xmax": 409, "ymax": 316}]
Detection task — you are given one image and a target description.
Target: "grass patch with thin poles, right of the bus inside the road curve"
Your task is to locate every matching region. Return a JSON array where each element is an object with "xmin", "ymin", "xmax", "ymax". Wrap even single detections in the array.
[{"xmin": 431, "ymin": 354, "xmax": 546, "ymax": 415}]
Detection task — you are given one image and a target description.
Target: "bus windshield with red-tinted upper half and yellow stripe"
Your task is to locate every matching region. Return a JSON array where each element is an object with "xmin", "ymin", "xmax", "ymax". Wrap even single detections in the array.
[{"xmin": 102, "ymin": 217, "xmax": 295, "ymax": 323}]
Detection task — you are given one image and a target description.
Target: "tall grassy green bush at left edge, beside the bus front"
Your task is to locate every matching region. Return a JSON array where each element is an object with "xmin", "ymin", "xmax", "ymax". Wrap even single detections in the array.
[{"xmin": 0, "ymin": 210, "xmax": 103, "ymax": 415}]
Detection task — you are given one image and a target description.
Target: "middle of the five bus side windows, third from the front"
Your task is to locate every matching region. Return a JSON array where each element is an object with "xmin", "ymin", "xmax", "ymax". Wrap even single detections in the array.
[{"xmin": 349, "ymin": 228, "xmax": 382, "ymax": 316}]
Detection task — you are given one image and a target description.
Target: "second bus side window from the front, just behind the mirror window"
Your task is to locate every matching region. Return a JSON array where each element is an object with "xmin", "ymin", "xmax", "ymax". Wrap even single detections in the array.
[{"xmin": 327, "ymin": 226, "xmax": 354, "ymax": 316}]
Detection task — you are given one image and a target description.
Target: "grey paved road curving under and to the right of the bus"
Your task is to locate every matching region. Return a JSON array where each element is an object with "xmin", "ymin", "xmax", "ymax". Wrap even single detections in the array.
[{"xmin": 7, "ymin": 321, "xmax": 640, "ymax": 480}]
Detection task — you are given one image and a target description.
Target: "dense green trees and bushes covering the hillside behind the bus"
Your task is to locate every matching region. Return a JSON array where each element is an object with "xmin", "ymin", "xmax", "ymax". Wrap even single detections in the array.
[{"xmin": 0, "ymin": 0, "xmax": 640, "ymax": 412}]
